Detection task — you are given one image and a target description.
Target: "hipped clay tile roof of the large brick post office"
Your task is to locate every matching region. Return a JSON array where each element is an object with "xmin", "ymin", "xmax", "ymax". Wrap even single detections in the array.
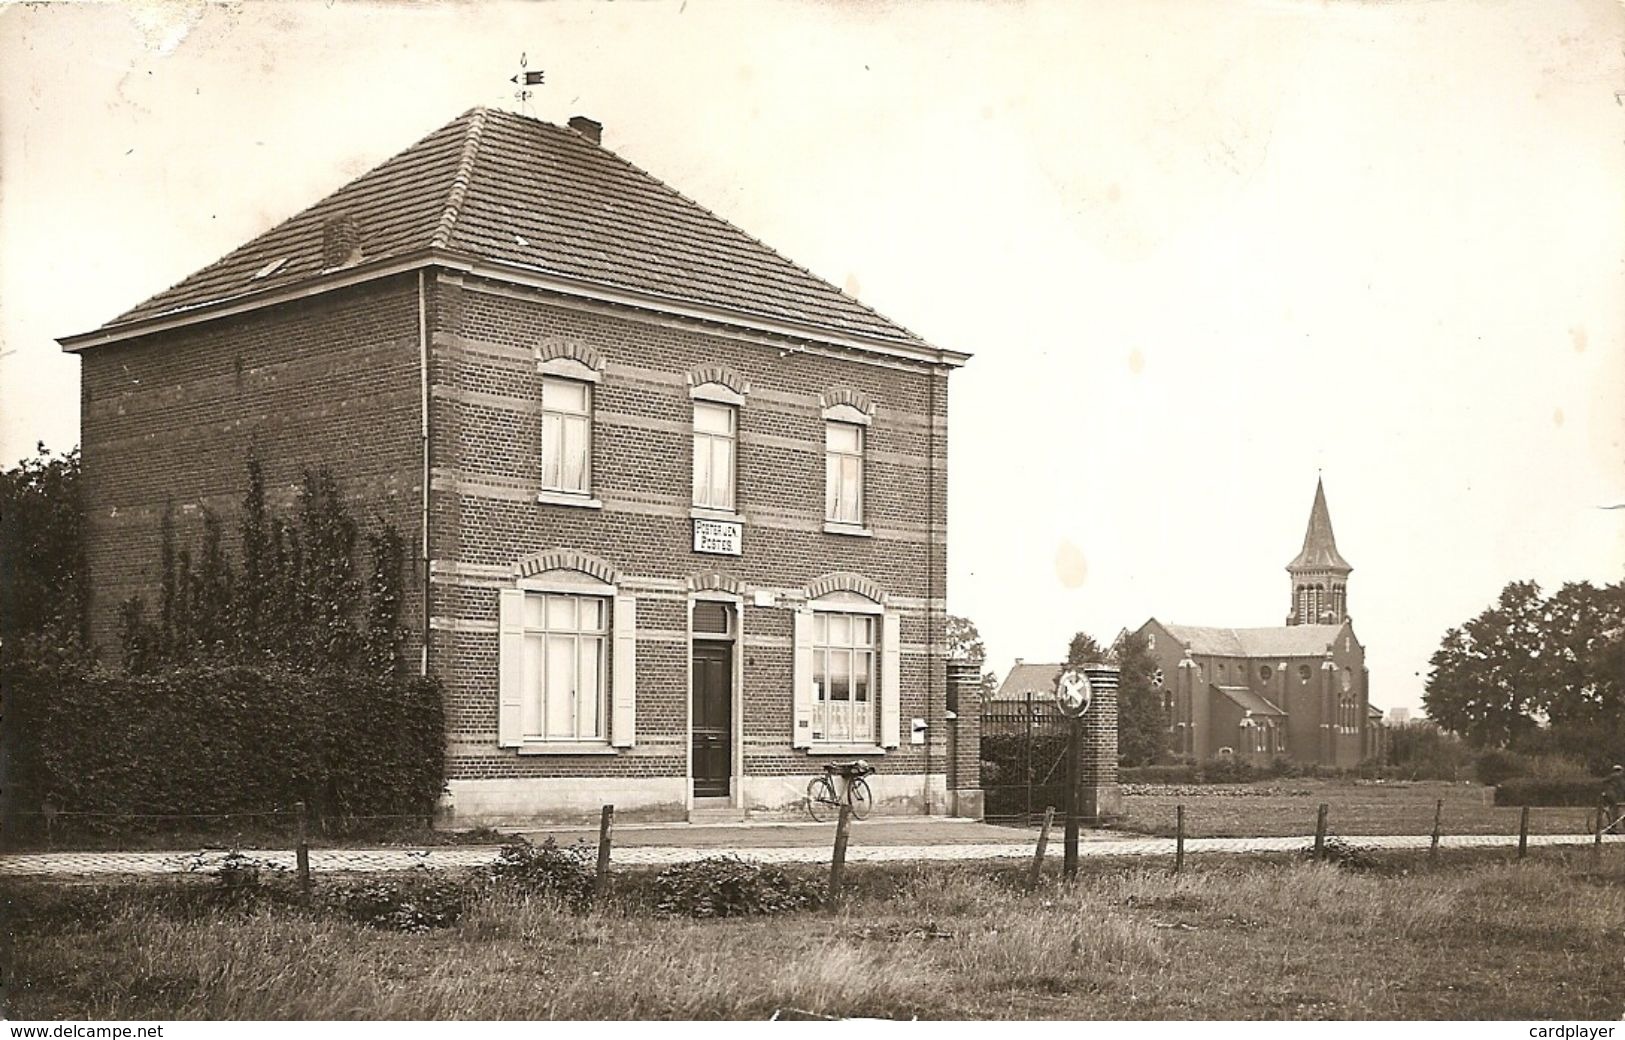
[{"xmin": 109, "ymin": 109, "xmax": 923, "ymax": 346}]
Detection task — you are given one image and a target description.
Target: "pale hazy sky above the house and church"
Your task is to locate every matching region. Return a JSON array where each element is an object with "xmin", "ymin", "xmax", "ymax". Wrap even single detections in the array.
[{"xmin": 0, "ymin": 0, "xmax": 1625, "ymax": 709}]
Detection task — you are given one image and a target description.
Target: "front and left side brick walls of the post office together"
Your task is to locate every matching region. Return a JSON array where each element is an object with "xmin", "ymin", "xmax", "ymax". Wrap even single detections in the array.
[{"xmin": 83, "ymin": 266, "xmax": 978, "ymax": 812}]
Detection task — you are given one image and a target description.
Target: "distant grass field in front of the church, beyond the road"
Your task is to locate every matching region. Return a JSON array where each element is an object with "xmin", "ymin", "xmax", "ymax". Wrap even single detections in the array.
[{"xmin": 1115, "ymin": 780, "xmax": 1589, "ymax": 837}]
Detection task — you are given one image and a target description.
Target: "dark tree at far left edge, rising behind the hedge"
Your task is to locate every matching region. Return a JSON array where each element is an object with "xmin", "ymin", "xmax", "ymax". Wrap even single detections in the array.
[{"xmin": 0, "ymin": 442, "xmax": 86, "ymax": 648}]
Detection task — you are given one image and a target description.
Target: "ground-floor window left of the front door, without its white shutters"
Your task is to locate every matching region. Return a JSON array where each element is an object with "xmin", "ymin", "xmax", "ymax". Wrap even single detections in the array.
[{"xmin": 522, "ymin": 592, "xmax": 609, "ymax": 741}]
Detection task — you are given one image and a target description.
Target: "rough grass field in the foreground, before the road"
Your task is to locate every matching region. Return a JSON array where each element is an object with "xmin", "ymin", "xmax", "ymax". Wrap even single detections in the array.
[{"xmin": 5, "ymin": 850, "xmax": 1625, "ymax": 1019}]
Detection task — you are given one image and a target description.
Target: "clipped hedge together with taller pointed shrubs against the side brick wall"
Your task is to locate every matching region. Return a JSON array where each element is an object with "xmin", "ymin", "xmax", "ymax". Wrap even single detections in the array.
[{"xmin": 7, "ymin": 462, "xmax": 444, "ymax": 837}]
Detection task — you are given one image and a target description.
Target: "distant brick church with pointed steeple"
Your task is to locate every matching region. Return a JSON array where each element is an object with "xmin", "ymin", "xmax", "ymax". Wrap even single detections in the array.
[{"xmin": 1139, "ymin": 483, "xmax": 1381, "ymax": 767}]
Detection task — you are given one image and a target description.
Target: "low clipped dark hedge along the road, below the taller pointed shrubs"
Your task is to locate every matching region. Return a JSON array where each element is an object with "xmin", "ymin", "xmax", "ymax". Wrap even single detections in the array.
[{"xmin": 7, "ymin": 665, "xmax": 445, "ymax": 829}]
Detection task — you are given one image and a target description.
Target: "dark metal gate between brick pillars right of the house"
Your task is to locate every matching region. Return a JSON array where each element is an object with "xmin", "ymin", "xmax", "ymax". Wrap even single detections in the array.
[{"xmin": 982, "ymin": 694, "xmax": 1071, "ymax": 824}]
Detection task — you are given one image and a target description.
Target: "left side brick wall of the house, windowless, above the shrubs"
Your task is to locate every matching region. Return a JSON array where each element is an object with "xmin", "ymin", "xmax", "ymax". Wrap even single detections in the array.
[{"xmin": 80, "ymin": 276, "xmax": 423, "ymax": 658}]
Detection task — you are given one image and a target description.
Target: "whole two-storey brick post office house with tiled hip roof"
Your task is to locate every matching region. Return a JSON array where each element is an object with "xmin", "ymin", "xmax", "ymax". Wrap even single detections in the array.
[{"xmin": 62, "ymin": 109, "xmax": 977, "ymax": 822}]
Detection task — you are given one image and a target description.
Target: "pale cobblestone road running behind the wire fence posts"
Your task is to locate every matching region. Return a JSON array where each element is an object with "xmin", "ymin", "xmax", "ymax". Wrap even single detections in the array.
[{"xmin": 0, "ymin": 834, "xmax": 1625, "ymax": 879}]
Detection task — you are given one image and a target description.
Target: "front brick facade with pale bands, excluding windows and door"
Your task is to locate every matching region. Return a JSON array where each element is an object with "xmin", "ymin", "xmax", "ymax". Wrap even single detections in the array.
[{"xmin": 431, "ymin": 278, "xmax": 947, "ymax": 778}]
